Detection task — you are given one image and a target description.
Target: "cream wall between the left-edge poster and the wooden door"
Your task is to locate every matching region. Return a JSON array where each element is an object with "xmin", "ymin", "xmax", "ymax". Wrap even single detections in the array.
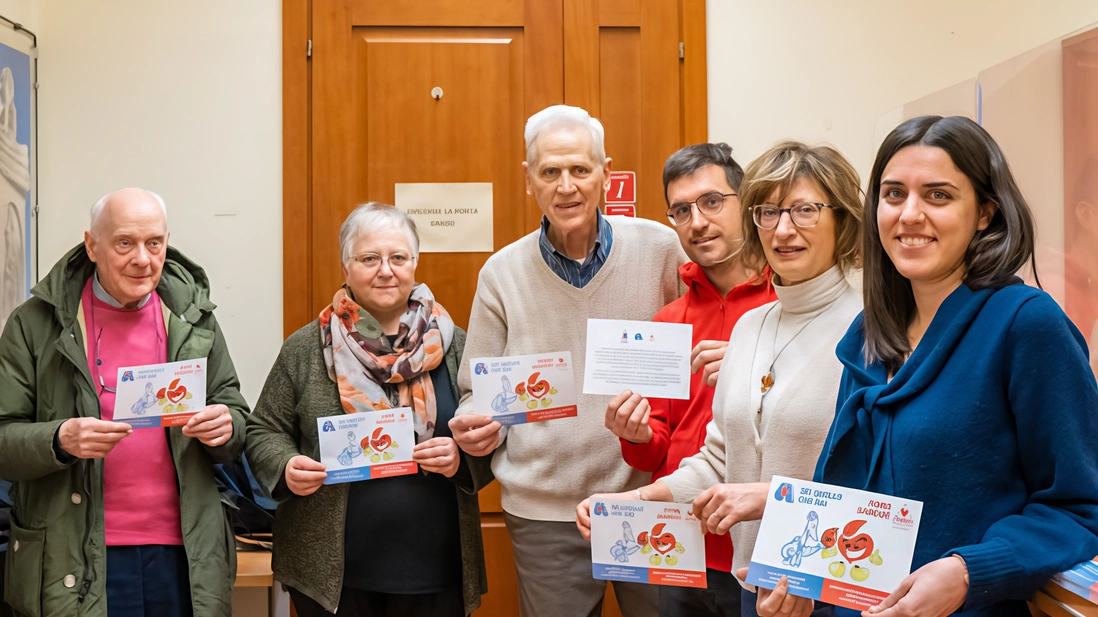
[{"xmin": 35, "ymin": 0, "xmax": 282, "ymax": 403}]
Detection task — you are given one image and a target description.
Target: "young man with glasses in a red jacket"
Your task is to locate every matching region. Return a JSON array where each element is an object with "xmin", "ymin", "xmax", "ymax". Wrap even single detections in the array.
[{"xmin": 606, "ymin": 144, "xmax": 777, "ymax": 617}]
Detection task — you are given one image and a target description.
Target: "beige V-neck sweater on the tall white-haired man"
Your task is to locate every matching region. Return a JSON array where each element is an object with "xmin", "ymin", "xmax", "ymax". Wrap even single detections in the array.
[{"xmin": 457, "ymin": 216, "xmax": 686, "ymax": 521}]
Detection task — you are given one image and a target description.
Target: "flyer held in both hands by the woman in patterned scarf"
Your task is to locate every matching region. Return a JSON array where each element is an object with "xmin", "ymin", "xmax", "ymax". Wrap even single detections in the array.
[{"xmin": 316, "ymin": 407, "xmax": 419, "ymax": 484}]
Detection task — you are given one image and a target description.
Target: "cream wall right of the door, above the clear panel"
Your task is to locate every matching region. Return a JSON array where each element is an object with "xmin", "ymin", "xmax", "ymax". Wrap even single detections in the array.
[{"xmin": 706, "ymin": 0, "xmax": 1098, "ymax": 180}]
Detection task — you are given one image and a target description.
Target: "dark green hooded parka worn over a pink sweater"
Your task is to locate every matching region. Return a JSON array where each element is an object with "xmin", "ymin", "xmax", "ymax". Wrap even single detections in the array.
[{"xmin": 0, "ymin": 245, "xmax": 248, "ymax": 617}]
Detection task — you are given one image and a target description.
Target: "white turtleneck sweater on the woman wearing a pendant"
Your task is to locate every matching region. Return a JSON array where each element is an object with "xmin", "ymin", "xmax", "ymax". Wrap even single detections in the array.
[{"xmin": 661, "ymin": 266, "xmax": 862, "ymax": 572}]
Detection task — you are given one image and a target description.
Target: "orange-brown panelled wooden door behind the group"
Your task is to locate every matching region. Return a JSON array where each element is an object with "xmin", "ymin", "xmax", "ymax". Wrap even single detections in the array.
[{"xmin": 283, "ymin": 0, "xmax": 706, "ymax": 617}]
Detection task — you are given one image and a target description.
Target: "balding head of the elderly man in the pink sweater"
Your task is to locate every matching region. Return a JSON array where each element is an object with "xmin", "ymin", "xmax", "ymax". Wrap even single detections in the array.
[{"xmin": 83, "ymin": 189, "xmax": 168, "ymax": 307}]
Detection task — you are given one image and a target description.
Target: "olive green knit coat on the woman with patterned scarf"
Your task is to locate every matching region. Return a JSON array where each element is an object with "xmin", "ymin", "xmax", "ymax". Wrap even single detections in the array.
[{"xmin": 247, "ymin": 321, "xmax": 492, "ymax": 615}]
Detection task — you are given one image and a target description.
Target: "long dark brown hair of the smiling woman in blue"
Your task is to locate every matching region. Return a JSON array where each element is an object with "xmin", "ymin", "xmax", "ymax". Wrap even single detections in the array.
[{"xmin": 862, "ymin": 115, "xmax": 1040, "ymax": 373}]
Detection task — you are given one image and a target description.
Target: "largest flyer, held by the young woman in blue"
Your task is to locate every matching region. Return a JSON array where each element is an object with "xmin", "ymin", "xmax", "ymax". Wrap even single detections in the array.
[{"xmin": 747, "ymin": 475, "xmax": 922, "ymax": 610}]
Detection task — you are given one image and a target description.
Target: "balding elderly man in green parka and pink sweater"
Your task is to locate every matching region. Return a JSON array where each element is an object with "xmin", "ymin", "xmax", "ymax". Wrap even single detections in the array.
[{"xmin": 0, "ymin": 189, "xmax": 248, "ymax": 617}]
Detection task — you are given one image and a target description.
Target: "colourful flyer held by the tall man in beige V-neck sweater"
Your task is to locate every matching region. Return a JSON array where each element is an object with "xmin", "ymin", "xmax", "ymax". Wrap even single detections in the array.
[{"xmin": 469, "ymin": 351, "xmax": 578, "ymax": 426}]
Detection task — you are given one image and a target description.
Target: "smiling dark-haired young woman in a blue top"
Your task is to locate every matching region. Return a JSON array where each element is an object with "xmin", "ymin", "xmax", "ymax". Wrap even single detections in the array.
[{"xmin": 759, "ymin": 116, "xmax": 1098, "ymax": 617}]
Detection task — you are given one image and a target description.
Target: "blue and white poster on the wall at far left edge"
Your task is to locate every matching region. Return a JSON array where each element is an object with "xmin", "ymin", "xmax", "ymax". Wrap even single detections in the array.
[{"xmin": 0, "ymin": 44, "xmax": 33, "ymax": 329}]
